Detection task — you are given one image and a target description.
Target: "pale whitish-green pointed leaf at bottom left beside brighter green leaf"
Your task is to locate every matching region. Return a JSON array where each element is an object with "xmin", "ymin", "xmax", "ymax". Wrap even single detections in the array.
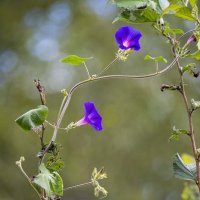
[{"xmin": 33, "ymin": 163, "xmax": 55, "ymax": 197}]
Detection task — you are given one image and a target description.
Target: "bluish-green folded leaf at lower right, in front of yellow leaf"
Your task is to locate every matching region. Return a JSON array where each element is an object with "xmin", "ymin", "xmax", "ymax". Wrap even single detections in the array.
[{"xmin": 173, "ymin": 153, "xmax": 197, "ymax": 182}]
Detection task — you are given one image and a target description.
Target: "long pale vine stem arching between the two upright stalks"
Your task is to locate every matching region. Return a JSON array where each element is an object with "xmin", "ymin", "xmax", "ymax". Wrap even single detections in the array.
[{"xmin": 41, "ymin": 56, "xmax": 180, "ymax": 160}]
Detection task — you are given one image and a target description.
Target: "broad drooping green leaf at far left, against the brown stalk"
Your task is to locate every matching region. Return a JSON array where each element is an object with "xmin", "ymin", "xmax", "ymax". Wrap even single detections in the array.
[{"xmin": 15, "ymin": 105, "xmax": 48, "ymax": 131}]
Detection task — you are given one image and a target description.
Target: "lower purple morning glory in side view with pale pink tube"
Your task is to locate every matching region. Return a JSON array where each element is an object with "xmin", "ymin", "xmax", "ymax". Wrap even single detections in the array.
[{"xmin": 76, "ymin": 102, "xmax": 103, "ymax": 131}]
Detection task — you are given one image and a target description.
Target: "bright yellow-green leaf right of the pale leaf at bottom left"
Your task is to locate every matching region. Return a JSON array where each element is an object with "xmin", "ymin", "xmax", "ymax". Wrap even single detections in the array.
[{"xmin": 51, "ymin": 172, "xmax": 63, "ymax": 196}]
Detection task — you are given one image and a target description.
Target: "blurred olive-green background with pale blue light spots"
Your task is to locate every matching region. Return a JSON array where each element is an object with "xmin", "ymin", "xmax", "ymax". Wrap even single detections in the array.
[{"xmin": 0, "ymin": 0, "xmax": 200, "ymax": 200}]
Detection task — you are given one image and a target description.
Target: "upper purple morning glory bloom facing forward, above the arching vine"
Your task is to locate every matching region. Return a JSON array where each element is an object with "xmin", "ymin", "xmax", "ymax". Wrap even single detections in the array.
[{"xmin": 115, "ymin": 26, "xmax": 142, "ymax": 51}]
